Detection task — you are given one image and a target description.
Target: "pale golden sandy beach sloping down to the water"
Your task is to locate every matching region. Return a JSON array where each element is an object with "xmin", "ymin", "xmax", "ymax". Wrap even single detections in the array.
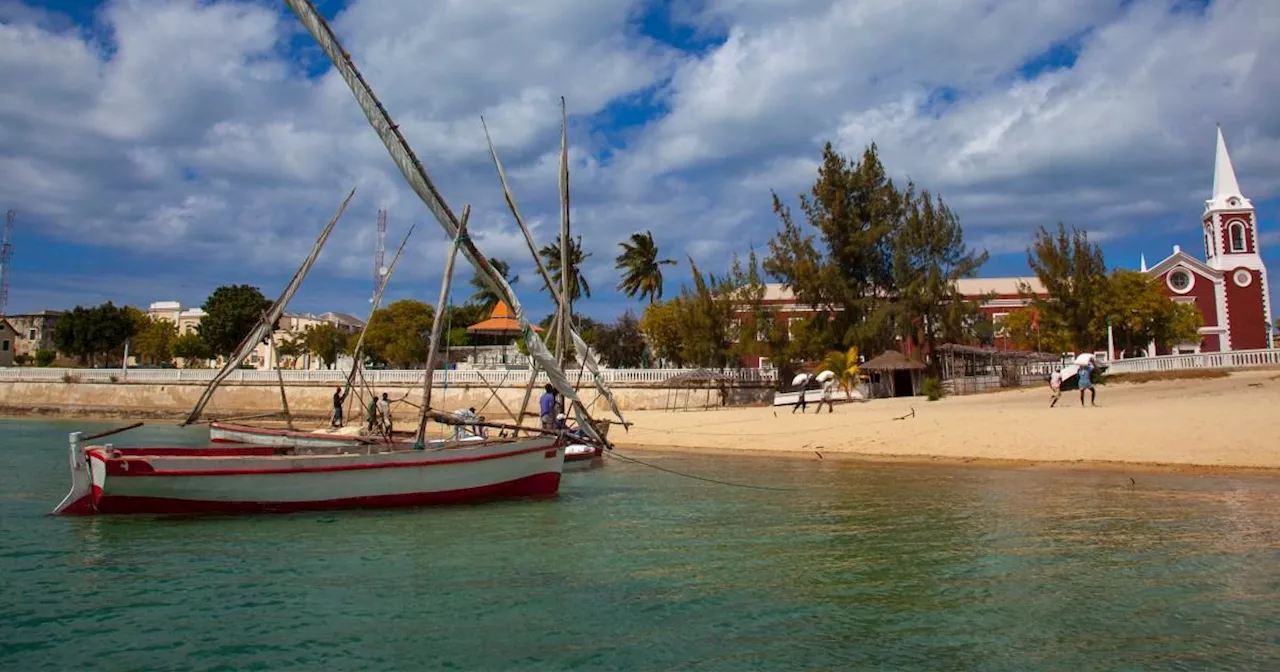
[{"xmin": 609, "ymin": 370, "xmax": 1280, "ymax": 471}]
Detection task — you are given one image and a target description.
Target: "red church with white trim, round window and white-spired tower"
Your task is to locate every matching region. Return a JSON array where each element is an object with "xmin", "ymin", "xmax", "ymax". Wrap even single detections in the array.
[{"xmin": 1142, "ymin": 128, "xmax": 1271, "ymax": 355}]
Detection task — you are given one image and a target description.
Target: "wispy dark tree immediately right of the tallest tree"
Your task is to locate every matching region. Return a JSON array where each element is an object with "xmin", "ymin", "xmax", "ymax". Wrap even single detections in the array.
[{"xmin": 892, "ymin": 191, "xmax": 988, "ymax": 360}]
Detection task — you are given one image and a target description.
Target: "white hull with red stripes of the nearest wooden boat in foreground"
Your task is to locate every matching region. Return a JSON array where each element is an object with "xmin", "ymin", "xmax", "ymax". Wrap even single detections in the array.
[{"xmin": 54, "ymin": 435, "xmax": 564, "ymax": 515}]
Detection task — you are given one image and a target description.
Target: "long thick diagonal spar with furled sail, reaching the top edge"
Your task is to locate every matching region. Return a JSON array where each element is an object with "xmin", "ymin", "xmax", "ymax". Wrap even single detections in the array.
[{"xmin": 284, "ymin": 0, "xmax": 603, "ymax": 443}]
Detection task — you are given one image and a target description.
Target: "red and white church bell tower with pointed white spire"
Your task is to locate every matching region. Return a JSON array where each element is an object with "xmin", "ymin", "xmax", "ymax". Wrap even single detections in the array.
[{"xmin": 1202, "ymin": 128, "xmax": 1271, "ymax": 349}]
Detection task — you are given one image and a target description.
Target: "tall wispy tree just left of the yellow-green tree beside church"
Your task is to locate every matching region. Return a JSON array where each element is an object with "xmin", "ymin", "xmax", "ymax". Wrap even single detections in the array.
[{"xmin": 1023, "ymin": 223, "xmax": 1107, "ymax": 352}]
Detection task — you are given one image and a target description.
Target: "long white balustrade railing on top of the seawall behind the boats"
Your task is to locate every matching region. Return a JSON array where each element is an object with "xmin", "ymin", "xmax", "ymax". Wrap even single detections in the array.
[{"xmin": 0, "ymin": 366, "xmax": 777, "ymax": 388}]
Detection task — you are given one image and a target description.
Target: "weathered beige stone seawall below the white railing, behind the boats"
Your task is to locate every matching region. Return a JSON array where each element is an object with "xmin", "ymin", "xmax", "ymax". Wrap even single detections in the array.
[{"xmin": 0, "ymin": 380, "xmax": 773, "ymax": 420}]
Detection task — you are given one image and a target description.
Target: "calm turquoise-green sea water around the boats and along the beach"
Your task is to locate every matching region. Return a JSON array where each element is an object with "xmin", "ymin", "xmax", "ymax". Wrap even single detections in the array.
[{"xmin": 0, "ymin": 420, "xmax": 1280, "ymax": 672}]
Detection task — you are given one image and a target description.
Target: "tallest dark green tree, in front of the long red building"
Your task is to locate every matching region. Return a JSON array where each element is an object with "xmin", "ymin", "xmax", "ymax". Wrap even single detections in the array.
[{"xmin": 764, "ymin": 142, "xmax": 914, "ymax": 351}]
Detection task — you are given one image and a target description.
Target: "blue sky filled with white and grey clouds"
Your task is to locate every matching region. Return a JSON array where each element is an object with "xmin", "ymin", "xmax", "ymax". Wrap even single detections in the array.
[{"xmin": 0, "ymin": 0, "xmax": 1280, "ymax": 319}]
